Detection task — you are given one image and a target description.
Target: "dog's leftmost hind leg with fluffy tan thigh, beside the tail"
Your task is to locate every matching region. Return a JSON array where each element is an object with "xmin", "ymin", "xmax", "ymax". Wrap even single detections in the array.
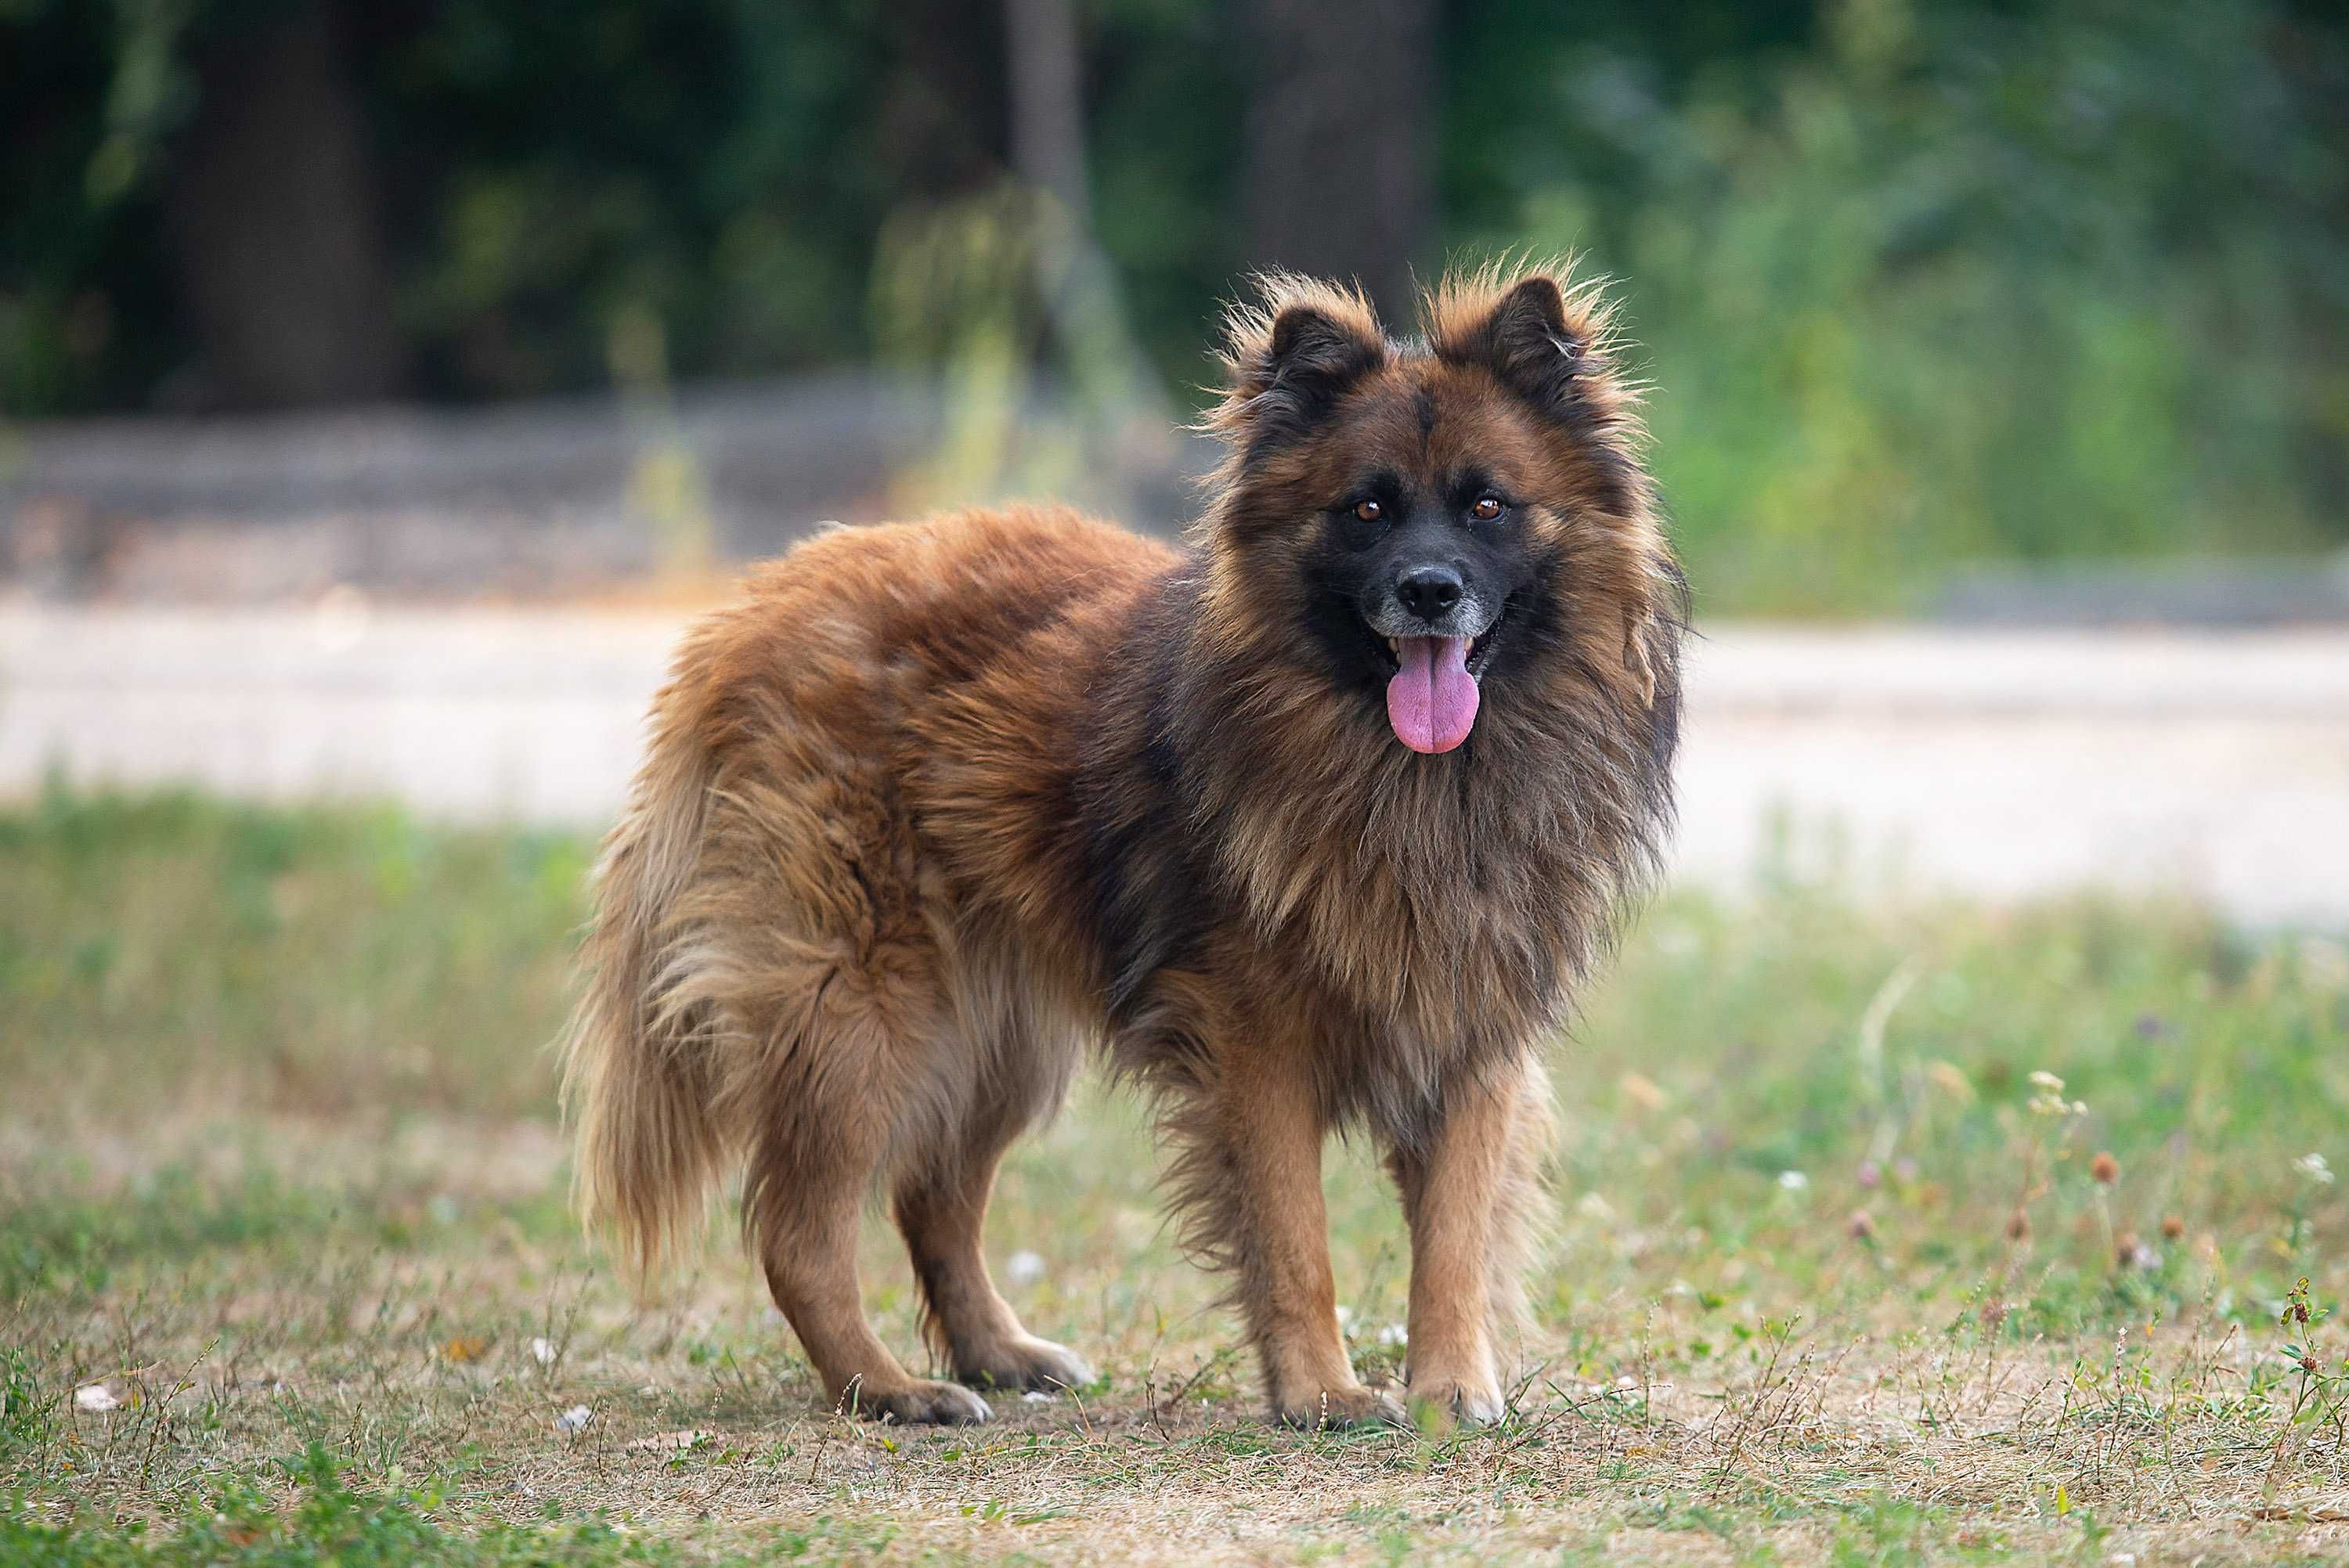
[{"xmin": 674, "ymin": 775, "xmax": 991, "ymax": 1422}]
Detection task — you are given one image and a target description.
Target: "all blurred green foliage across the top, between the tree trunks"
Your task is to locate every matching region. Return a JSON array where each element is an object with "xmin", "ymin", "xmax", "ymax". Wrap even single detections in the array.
[{"xmin": 0, "ymin": 0, "xmax": 2349, "ymax": 611}]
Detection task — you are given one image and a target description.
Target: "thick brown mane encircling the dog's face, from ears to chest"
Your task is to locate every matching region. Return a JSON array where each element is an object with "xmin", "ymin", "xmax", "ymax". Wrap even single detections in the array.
[{"xmin": 1174, "ymin": 268, "xmax": 1687, "ymax": 1103}]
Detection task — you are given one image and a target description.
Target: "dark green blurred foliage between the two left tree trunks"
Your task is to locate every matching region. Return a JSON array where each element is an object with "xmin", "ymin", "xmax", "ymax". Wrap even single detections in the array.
[{"xmin": 381, "ymin": 0, "xmax": 888, "ymax": 397}]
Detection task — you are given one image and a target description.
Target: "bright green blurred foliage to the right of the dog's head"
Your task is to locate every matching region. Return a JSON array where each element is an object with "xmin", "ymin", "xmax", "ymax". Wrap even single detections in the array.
[{"xmin": 1489, "ymin": 0, "xmax": 2349, "ymax": 611}]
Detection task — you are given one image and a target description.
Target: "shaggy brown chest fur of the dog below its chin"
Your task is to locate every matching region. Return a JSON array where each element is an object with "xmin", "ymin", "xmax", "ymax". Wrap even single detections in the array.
[{"xmin": 1177, "ymin": 582, "xmax": 1677, "ymax": 1072}]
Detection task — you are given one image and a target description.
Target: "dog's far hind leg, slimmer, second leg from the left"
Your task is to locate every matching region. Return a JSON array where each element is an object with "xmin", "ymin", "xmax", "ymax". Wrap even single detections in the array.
[{"xmin": 897, "ymin": 1096, "xmax": 1092, "ymax": 1390}]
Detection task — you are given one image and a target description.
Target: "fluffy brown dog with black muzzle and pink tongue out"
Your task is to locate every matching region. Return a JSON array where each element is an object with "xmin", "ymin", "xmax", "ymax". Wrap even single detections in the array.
[{"xmin": 566, "ymin": 272, "xmax": 1684, "ymax": 1425}]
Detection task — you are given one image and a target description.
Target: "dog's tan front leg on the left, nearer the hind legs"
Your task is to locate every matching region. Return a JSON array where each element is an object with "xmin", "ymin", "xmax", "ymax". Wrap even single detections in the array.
[{"xmin": 1182, "ymin": 1056, "xmax": 1405, "ymax": 1427}]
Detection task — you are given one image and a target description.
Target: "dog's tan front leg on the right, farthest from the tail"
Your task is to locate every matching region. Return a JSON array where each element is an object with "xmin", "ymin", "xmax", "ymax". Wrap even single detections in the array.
[{"xmin": 1388, "ymin": 1063, "xmax": 1546, "ymax": 1425}]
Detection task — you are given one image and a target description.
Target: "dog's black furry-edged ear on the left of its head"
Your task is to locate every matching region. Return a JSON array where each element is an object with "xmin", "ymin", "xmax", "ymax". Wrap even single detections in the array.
[{"xmin": 1210, "ymin": 272, "xmax": 1386, "ymax": 449}]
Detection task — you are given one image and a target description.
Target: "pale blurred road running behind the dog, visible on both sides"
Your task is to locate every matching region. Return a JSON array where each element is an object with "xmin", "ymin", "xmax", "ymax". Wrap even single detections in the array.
[{"xmin": 0, "ymin": 597, "xmax": 2349, "ymax": 925}]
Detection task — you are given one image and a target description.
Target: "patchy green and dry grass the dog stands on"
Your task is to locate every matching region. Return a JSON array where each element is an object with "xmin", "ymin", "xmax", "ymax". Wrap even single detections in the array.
[{"xmin": 0, "ymin": 793, "xmax": 2349, "ymax": 1566}]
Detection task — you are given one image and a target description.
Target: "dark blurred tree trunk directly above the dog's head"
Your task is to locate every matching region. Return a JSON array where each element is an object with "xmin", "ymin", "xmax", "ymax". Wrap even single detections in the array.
[{"xmin": 1245, "ymin": 0, "xmax": 1435, "ymax": 326}]
